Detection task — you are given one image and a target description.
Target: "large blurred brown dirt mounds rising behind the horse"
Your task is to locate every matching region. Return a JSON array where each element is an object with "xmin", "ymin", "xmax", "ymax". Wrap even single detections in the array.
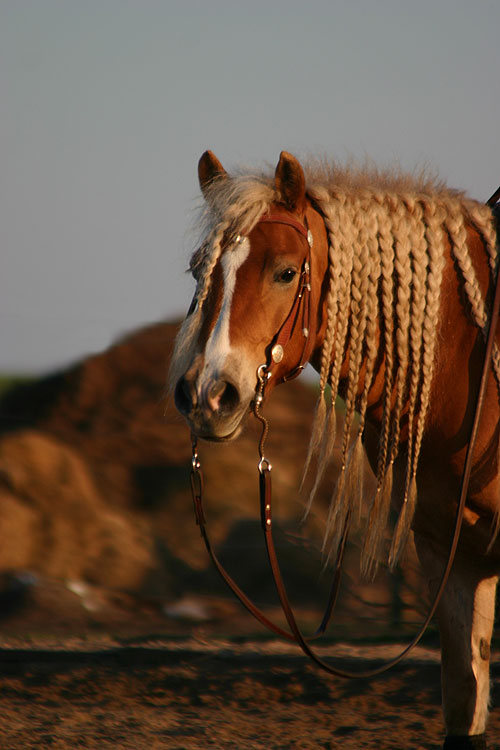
[{"xmin": 0, "ymin": 323, "xmax": 426, "ymax": 626}]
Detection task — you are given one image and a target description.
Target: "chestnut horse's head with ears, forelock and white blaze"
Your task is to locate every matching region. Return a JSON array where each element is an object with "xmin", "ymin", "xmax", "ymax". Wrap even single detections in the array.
[{"xmin": 173, "ymin": 151, "xmax": 326, "ymax": 441}]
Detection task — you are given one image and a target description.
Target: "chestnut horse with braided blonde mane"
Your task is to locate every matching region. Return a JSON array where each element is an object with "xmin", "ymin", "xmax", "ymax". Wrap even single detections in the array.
[{"xmin": 170, "ymin": 151, "xmax": 500, "ymax": 750}]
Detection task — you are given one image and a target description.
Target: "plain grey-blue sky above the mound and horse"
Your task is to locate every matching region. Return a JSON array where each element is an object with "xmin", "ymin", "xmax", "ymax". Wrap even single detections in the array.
[{"xmin": 0, "ymin": 0, "xmax": 500, "ymax": 373}]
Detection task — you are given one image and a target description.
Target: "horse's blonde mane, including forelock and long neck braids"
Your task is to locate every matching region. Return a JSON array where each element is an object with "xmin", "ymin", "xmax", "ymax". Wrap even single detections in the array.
[{"xmin": 171, "ymin": 161, "xmax": 500, "ymax": 573}]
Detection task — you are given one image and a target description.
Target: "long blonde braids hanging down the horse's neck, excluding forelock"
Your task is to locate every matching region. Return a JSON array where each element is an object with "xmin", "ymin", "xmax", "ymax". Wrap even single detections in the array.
[{"xmin": 308, "ymin": 175, "xmax": 500, "ymax": 573}]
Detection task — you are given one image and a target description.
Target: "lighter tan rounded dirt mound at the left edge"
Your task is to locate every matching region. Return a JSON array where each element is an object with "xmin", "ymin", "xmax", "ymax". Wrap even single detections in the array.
[{"xmin": 0, "ymin": 430, "xmax": 154, "ymax": 589}]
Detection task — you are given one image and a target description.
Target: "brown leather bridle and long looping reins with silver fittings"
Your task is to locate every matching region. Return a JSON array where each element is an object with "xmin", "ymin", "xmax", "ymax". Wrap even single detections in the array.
[{"xmin": 191, "ymin": 195, "xmax": 500, "ymax": 678}]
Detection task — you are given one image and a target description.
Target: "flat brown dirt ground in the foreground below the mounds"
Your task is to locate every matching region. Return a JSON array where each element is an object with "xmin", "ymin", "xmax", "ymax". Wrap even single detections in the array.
[{"xmin": 0, "ymin": 630, "xmax": 500, "ymax": 750}]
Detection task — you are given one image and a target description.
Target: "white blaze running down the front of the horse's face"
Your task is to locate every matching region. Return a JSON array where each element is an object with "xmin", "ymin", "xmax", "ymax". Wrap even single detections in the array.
[{"xmin": 204, "ymin": 237, "xmax": 250, "ymax": 377}]
